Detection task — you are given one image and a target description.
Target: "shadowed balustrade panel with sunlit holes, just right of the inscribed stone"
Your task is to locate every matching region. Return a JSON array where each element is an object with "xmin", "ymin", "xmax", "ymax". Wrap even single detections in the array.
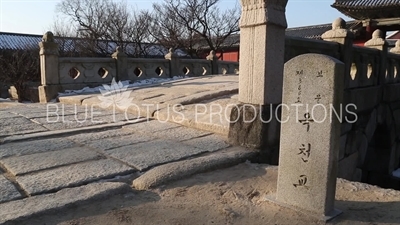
[{"xmin": 354, "ymin": 46, "xmax": 381, "ymax": 88}]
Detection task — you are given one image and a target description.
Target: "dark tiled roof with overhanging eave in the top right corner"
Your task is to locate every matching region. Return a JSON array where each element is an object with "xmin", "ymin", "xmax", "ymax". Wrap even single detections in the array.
[{"xmin": 331, "ymin": 0, "xmax": 400, "ymax": 20}]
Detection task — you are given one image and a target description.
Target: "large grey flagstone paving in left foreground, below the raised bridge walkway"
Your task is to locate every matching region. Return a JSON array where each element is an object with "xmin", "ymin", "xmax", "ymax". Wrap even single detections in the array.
[{"xmin": 0, "ymin": 94, "xmax": 255, "ymax": 224}]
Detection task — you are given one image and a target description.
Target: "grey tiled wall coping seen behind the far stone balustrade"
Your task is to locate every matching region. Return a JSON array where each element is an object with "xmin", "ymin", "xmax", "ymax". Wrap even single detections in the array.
[{"xmin": 0, "ymin": 32, "xmax": 186, "ymax": 57}]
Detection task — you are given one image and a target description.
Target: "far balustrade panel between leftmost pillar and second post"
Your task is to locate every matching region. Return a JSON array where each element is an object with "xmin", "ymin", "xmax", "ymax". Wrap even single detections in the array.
[{"xmin": 59, "ymin": 58, "xmax": 116, "ymax": 84}]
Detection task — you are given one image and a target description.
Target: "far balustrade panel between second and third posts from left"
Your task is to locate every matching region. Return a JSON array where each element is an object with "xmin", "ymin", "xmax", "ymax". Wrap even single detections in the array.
[{"xmin": 127, "ymin": 58, "xmax": 170, "ymax": 82}]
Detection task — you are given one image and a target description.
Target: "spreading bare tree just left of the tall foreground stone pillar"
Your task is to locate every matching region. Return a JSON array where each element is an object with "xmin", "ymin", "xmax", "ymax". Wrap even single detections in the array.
[{"xmin": 151, "ymin": 0, "xmax": 240, "ymax": 56}]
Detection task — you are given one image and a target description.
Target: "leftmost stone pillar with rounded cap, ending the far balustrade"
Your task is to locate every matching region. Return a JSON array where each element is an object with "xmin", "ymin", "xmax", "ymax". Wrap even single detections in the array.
[{"xmin": 39, "ymin": 31, "xmax": 60, "ymax": 103}]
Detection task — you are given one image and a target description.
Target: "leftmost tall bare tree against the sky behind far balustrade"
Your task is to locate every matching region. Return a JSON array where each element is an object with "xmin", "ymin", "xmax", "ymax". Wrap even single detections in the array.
[{"xmin": 57, "ymin": 0, "xmax": 149, "ymax": 56}]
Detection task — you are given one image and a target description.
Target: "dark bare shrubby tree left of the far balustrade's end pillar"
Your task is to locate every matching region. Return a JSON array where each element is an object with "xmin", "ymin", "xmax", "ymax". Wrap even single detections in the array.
[{"xmin": 0, "ymin": 49, "xmax": 40, "ymax": 102}]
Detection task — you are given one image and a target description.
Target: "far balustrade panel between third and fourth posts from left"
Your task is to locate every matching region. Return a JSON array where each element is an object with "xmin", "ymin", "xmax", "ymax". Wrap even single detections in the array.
[{"xmin": 180, "ymin": 59, "xmax": 212, "ymax": 77}]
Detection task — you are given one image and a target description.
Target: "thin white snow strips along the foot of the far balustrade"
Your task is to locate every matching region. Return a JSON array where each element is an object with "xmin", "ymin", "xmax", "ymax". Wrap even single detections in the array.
[{"xmin": 58, "ymin": 76, "xmax": 187, "ymax": 97}]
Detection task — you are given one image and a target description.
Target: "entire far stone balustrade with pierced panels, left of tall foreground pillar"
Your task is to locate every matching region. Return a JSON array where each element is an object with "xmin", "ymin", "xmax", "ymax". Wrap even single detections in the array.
[{"xmin": 38, "ymin": 32, "xmax": 239, "ymax": 103}]
